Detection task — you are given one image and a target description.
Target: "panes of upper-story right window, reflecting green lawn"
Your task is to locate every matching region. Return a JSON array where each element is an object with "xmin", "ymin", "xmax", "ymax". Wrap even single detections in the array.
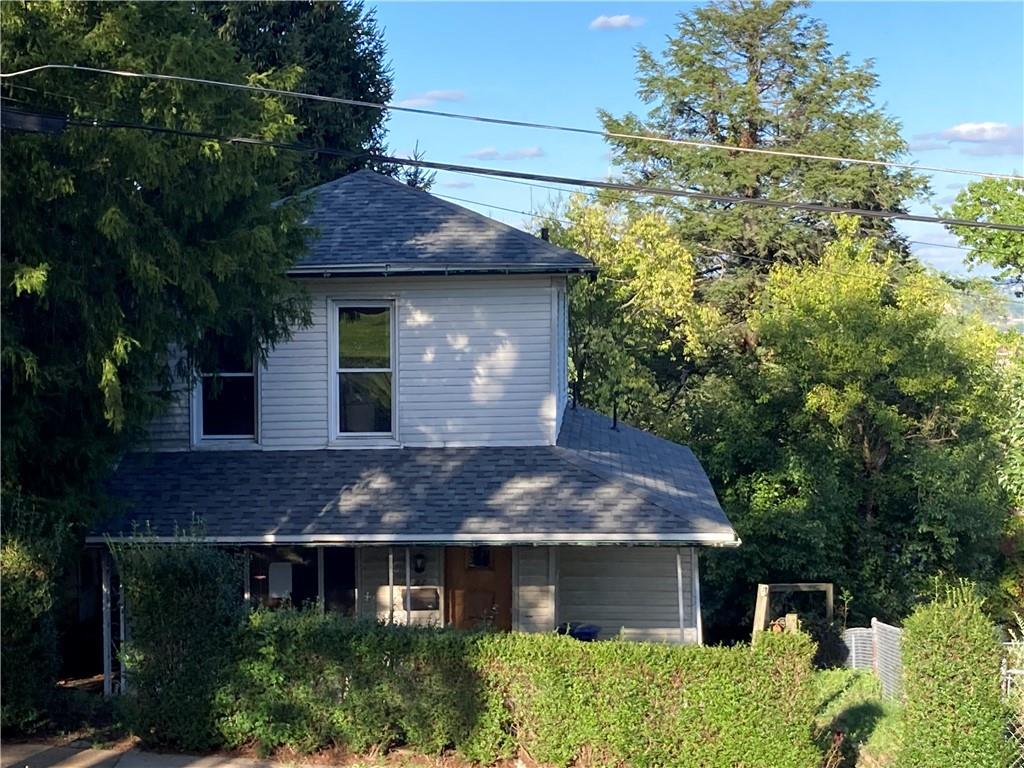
[{"xmin": 333, "ymin": 302, "xmax": 395, "ymax": 437}]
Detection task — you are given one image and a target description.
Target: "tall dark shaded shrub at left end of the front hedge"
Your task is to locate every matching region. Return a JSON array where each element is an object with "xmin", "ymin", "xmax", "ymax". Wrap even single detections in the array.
[{"xmin": 112, "ymin": 540, "xmax": 245, "ymax": 750}]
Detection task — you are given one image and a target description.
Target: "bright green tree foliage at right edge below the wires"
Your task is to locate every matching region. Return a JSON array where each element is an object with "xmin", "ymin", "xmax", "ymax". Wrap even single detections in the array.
[{"xmin": 949, "ymin": 178, "xmax": 1024, "ymax": 283}]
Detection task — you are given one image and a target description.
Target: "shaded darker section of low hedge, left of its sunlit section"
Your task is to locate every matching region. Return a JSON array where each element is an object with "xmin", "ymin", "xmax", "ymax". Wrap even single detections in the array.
[{"xmin": 217, "ymin": 608, "xmax": 481, "ymax": 754}]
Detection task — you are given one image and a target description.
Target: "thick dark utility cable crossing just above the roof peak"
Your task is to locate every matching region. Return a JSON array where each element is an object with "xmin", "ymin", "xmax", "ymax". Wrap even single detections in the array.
[{"xmin": 4, "ymin": 102, "xmax": 1024, "ymax": 232}]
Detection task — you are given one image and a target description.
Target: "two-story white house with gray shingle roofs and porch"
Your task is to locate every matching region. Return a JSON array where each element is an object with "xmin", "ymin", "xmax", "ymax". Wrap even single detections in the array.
[{"xmin": 89, "ymin": 171, "xmax": 738, "ymax": 684}]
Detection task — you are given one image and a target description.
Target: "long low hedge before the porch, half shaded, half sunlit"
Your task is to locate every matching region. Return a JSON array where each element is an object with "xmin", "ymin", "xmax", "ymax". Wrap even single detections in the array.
[{"xmin": 211, "ymin": 610, "xmax": 820, "ymax": 766}]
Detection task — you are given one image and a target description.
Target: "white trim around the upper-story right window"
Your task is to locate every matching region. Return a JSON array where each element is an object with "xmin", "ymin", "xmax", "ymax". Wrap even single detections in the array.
[{"xmin": 327, "ymin": 297, "xmax": 399, "ymax": 447}]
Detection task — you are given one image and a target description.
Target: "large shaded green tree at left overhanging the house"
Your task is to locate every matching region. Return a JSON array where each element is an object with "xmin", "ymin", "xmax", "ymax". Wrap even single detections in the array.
[{"xmin": 0, "ymin": 3, "xmax": 307, "ymax": 535}]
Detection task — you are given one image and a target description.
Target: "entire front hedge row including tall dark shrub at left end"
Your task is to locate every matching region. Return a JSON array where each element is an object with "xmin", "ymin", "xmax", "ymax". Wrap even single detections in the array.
[{"xmin": 119, "ymin": 548, "xmax": 820, "ymax": 768}]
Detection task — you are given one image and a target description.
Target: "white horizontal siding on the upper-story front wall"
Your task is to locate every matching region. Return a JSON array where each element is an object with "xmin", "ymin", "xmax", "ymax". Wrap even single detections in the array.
[{"xmin": 142, "ymin": 275, "xmax": 565, "ymax": 450}]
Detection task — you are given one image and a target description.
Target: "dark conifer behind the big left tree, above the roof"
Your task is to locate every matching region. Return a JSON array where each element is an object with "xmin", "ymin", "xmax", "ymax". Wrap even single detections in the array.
[{"xmin": 200, "ymin": 0, "xmax": 398, "ymax": 191}]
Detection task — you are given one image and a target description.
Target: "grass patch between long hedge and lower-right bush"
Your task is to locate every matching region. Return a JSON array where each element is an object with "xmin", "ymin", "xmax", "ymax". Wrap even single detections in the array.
[{"xmin": 815, "ymin": 669, "xmax": 901, "ymax": 767}]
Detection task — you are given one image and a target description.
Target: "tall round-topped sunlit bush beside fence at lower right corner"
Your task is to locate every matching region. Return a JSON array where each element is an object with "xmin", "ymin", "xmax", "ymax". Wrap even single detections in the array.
[{"xmin": 897, "ymin": 586, "xmax": 1011, "ymax": 768}]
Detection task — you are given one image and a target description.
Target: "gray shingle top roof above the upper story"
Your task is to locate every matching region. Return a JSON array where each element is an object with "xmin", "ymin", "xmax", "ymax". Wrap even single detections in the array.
[{"xmin": 292, "ymin": 171, "xmax": 594, "ymax": 274}]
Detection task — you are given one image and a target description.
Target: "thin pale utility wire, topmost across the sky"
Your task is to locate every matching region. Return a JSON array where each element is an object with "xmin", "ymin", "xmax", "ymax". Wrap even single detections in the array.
[{"xmin": 0, "ymin": 63, "xmax": 1024, "ymax": 179}]
